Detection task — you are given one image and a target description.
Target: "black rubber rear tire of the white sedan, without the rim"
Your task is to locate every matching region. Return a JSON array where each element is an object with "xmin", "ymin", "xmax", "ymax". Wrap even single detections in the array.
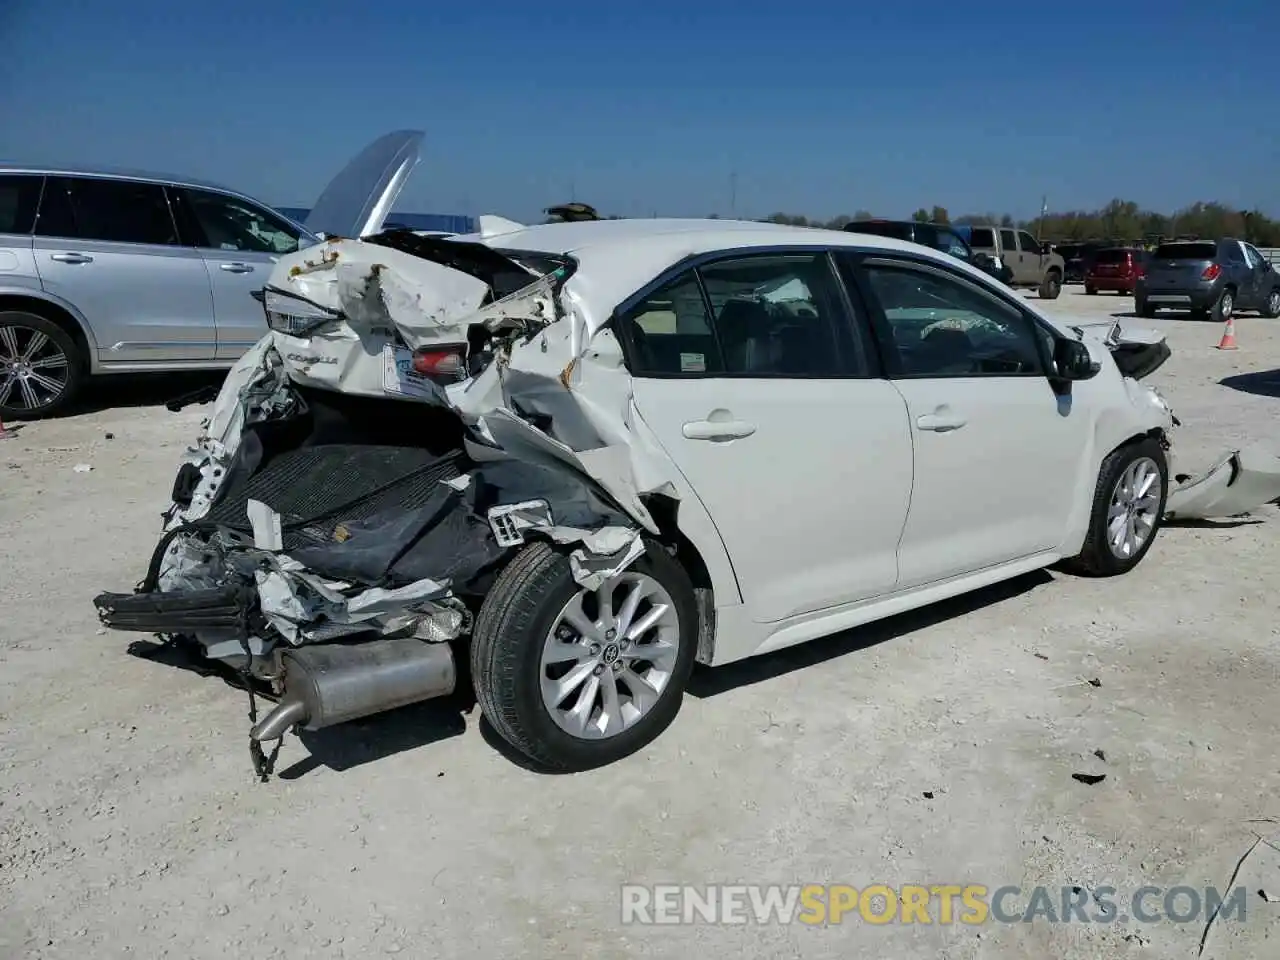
[{"xmin": 471, "ymin": 541, "xmax": 698, "ymax": 773}]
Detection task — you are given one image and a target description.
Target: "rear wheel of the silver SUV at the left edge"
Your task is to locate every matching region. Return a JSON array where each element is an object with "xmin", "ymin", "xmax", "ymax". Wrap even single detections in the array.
[{"xmin": 0, "ymin": 310, "xmax": 86, "ymax": 422}]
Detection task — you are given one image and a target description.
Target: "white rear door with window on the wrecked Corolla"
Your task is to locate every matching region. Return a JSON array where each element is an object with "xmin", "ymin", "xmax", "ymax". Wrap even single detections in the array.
[{"xmin": 614, "ymin": 248, "xmax": 913, "ymax": 623}]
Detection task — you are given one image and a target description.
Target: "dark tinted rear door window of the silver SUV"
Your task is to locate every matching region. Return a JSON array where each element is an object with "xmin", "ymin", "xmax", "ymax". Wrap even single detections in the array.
[{"xmin": 36, "ymin": 177, "xmax": 178, "ymax": 246}]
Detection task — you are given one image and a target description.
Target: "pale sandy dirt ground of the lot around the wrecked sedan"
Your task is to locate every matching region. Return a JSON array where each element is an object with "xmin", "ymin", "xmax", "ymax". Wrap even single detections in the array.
[{"xmin": 0, "ymin": 288, "xmax": 1280, "ymax": 960}]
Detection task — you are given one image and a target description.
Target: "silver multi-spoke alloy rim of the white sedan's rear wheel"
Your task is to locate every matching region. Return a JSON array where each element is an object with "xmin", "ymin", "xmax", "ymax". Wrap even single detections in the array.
[{"xmin": 539, "ymin": 571, "xmax": 681, "ymax": 740}]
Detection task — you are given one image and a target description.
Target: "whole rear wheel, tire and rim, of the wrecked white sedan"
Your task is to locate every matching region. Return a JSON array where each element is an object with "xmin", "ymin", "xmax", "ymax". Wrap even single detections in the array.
[{"xmin": 471, "ymin": 543, "xmax": 698, "ymax": 772}]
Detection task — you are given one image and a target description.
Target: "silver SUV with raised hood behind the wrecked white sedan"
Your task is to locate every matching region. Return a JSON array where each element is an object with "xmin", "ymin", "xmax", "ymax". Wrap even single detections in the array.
[{"xmin": 0, "ymin": 131, "xmax": 422, "ymax": 420}]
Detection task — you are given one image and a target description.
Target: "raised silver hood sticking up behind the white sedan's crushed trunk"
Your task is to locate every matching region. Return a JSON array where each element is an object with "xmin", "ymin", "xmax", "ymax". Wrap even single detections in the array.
[{"xmin": 302, "ymin": 131, "xmax": 424, "ymax": 237}]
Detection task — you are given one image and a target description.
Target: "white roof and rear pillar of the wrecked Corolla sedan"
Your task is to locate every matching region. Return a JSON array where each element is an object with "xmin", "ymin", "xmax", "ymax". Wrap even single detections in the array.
[{"xmin": 453, "ymin": 219, "xmax": 1008, "ymax": 334}]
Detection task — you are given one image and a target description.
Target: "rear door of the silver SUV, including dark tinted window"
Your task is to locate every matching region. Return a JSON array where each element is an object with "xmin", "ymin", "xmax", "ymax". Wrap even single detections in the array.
[{"xmin": 32, "ymin": 177, "xmax": 218, "ymax": 365}]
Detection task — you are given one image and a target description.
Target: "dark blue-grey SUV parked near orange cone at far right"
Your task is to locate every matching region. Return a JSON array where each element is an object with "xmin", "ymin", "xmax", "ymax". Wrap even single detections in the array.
[{"xmin": 1133, "ymin": 239, "xmax": 1280, "ymax": 323}]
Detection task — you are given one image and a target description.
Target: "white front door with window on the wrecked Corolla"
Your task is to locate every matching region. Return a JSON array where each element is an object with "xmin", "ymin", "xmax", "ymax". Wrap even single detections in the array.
[{"xmin": 849, "ymin": 256, "xmax": 1091, "ymax": 589}]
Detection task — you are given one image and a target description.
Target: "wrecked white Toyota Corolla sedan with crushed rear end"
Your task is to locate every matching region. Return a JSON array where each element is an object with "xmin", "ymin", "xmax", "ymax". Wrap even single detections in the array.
[{"xmin": 95, "ymin": 180, "xmax": 1280, "ymax": 776}]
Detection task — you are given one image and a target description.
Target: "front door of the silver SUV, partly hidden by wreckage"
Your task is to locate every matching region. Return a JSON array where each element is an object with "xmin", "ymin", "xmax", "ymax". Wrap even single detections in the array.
[{"xmin": 169, "ymin": 187, "xmax": 301, "ymax": 360}]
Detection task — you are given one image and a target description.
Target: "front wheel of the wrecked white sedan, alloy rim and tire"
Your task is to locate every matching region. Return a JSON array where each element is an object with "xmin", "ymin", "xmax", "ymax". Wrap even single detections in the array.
[{"xmin": 1064, "ymin": 438, "xmax": 1169, "ymax": 576}]
